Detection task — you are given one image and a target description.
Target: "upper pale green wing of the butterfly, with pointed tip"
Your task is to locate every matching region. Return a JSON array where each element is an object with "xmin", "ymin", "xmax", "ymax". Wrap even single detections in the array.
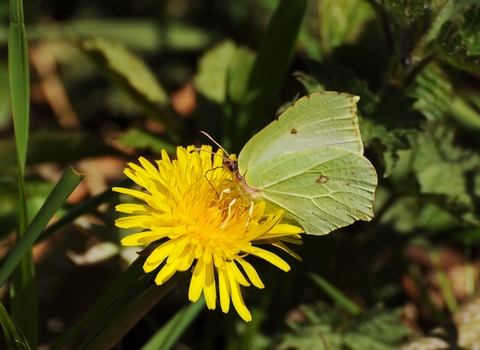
[{"xmin": 238, "ymin": 92, "xmax": 363, "ymax": 175}]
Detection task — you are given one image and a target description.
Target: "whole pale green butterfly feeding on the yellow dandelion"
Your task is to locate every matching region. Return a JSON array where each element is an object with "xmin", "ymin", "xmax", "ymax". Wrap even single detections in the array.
[{"xmin": 218, "ymin": 92, "xmax": 377, "ymax": 235}]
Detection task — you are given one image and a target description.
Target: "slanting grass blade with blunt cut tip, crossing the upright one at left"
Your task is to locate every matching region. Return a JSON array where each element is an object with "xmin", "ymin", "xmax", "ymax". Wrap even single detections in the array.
[{"xmin": 0, "ymin": 168, "xmax": 83, "ymax": 288}]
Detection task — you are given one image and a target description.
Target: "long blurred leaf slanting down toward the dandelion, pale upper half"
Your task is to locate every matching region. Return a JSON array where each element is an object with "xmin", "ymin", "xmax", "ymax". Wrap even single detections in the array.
[{"xmin": 79, "ymin": 37, "xmax": 183, "ymax": 140}]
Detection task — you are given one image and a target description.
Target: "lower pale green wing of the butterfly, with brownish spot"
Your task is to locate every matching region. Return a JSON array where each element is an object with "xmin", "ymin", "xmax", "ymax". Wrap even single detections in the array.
[{"xmin": 245, "ymin": 148, "xmax": 377, "ymax": 235}]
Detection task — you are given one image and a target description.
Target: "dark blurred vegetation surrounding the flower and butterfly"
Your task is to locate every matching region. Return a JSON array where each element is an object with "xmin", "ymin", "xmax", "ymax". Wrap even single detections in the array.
[{"xmin": 0, "ymin": 0, "xmax": 480, "ymax": 350}]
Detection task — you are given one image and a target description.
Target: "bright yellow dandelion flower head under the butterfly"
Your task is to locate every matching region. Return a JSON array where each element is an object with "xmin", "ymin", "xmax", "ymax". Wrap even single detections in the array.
[{"xmin": 113, "ymin": 146, "xmax": 303, "ymax": 322}]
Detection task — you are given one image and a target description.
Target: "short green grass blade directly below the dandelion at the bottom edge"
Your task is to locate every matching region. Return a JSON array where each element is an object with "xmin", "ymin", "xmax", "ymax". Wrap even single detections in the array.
[{"xmin": 141, "ymin": 297, "xmax": 205, "ymax": 350}]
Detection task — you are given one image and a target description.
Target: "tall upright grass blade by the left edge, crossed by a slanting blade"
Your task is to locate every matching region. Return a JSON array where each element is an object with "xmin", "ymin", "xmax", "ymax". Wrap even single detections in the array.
[{"xmin": 8, "ymin": 0, "xmax": 38, "ymax": 349}]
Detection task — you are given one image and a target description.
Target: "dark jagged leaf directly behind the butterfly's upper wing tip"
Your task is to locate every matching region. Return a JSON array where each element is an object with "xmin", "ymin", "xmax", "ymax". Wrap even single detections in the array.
[{"xmin": 295, "ymin": 60, "xmax": 425, "ymax": 176}]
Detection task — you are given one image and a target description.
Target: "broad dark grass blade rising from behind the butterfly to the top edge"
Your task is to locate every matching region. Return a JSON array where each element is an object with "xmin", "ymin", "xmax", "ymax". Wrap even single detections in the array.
[{"xmin": 231, "ymin": 0, "xmax": 307, "ymax": 150}]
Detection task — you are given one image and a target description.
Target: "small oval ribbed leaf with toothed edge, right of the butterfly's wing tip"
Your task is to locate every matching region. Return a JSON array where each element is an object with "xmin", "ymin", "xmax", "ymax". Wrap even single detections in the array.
[{"xmin": 408, "ymin": 63, "xmax": 454, "ymax": 121}]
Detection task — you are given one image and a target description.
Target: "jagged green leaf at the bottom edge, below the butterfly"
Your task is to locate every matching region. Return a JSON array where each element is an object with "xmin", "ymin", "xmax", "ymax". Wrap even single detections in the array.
[{"xmin": 278, "ymin": 303, "xmax": 412, "ymax": 350}]
